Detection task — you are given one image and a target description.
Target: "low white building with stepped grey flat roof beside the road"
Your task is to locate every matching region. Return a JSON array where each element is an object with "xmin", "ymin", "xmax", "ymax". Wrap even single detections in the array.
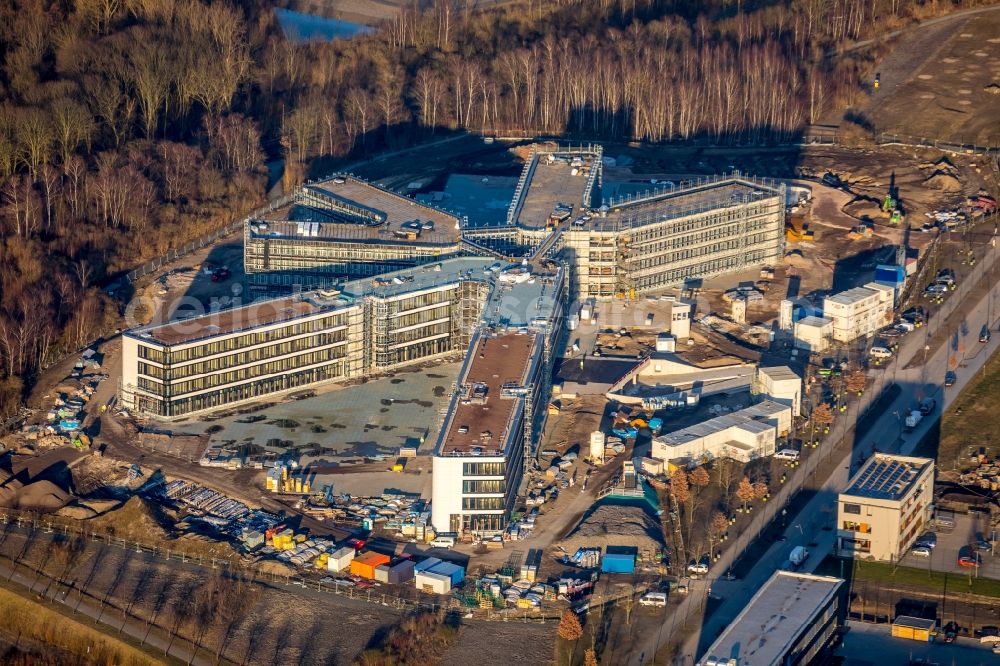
[{"xmin": 653, "ymin": 400, "xmax": 792, "ymax": 462}]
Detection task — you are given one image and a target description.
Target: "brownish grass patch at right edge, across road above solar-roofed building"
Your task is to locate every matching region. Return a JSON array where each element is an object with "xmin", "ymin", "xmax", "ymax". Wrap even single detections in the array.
[{"xmin": 937, "ymin": 355, "xmax": 1000, "ymax": 470}]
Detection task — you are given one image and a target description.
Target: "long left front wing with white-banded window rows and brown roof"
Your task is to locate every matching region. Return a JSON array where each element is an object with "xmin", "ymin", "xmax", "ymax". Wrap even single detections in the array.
[{"xmin": 121, "ymin": 259, "xmax": 492, "ymax": 419}]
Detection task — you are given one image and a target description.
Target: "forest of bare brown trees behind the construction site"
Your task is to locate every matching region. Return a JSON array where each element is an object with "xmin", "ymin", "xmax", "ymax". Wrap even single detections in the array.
[{"xmin": 0, "ymin": 0, "xmax": 992, "ymax": 416}]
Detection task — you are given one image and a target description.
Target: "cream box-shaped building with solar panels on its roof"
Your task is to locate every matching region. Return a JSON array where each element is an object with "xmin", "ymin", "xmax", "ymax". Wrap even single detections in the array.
[{"xmin": 837, "ymin": 453, "xmax": 934, "ymax": 561}]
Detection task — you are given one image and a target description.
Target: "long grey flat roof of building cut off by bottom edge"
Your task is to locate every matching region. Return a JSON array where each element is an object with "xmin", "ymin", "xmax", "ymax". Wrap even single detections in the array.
[{"xmin": 698, "ymin": 571, "xmax": 844, "ymax": 666}]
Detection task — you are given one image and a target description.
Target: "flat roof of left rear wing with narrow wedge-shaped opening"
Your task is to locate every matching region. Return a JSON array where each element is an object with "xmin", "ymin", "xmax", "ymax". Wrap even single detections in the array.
[{"xmin": 249, "ymin": 175, "xmax": 461, "ymax": 245}]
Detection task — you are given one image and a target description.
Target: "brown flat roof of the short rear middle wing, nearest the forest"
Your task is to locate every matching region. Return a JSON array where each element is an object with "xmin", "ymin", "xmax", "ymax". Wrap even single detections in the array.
[{"xmin": 511, "ymin": 151, "xmax": 601, "ymax": 229}]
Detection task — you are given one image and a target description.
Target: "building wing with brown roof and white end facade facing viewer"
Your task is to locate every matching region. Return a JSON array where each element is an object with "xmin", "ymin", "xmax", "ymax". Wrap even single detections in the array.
[{"xmin": 431, "ymin": 268, "xmax": 563, "ymax": 536}]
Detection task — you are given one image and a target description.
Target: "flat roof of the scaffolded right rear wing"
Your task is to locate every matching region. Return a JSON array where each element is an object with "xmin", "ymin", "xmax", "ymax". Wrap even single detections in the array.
[{"xmin": 594, "ymin": 176, "xmax": 778, "ymax": 230}]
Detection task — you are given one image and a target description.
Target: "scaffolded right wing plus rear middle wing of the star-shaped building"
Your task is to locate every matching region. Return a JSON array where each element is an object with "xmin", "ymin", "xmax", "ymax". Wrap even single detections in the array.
[{"xmin": 466, "ymin": 146, "xmax": 785, "ymax": 298}]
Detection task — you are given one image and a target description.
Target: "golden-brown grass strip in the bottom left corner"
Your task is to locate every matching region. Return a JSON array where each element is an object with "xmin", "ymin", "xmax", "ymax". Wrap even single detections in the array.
[{"xmin": 0, "ymin": 588, "xmax": 176, "ymax": 666}]
